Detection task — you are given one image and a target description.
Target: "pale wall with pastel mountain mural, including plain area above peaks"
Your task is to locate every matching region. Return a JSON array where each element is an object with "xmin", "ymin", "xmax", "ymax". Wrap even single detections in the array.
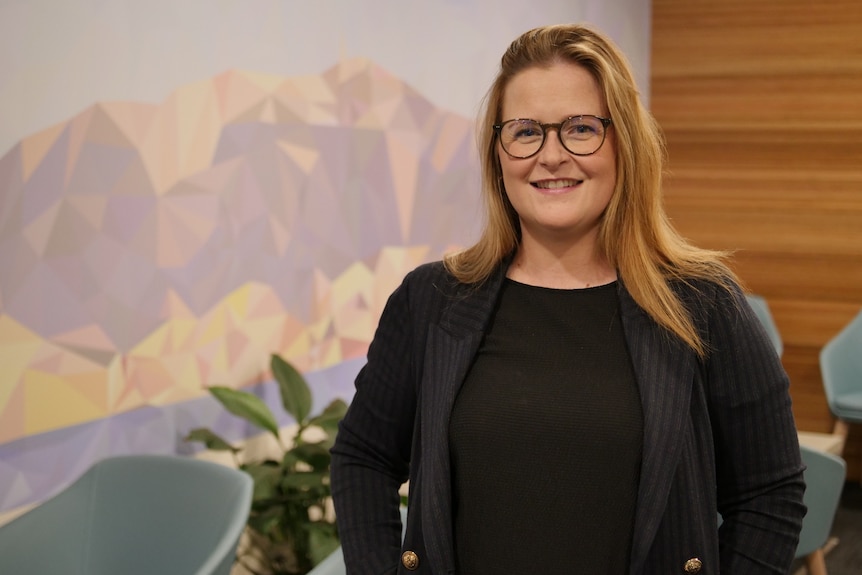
[{"xmin": 0, "ymin": 0, "xmax": 650, "ymax": 521}]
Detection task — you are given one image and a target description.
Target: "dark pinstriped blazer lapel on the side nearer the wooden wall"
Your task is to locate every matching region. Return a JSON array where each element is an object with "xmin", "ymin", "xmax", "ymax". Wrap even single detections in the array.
[{"xmin": 620, "ymin": 283, "xmax": 697, "ymax": 573}]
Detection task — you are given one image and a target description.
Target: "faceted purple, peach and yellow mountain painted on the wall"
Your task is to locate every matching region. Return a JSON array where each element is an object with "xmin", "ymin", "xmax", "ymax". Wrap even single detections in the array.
[{"xmin": 0, "ymin": 59, "xmax": 481, "ymax": 444}]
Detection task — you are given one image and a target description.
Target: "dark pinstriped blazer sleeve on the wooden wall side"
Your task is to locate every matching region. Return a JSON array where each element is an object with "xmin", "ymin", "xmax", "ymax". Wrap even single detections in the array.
[{"xmin": 705, "ymin": 282, "xmax": 805, "ymax": 575}]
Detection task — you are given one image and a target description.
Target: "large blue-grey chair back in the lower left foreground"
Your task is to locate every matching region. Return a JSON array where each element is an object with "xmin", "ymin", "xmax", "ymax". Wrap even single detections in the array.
[{"xmin": 0, "ymin": 455, "xmax": 253, "ymax": 575}]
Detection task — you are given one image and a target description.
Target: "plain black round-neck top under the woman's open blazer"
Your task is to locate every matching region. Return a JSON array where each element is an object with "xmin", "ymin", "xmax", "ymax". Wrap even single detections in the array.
[{"xmin": 450, "ymin": 279, "xmax": 643, "ymax": 575}]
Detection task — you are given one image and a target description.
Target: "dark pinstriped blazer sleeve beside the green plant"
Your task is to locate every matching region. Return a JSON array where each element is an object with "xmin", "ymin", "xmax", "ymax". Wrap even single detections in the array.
[{"xmin": 331, "ymin": 272, "xmax": 416, "ymax": 575}]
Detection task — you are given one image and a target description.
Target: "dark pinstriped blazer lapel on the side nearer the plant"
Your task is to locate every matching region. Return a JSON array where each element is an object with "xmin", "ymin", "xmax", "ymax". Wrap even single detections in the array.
[{"xmin": 419, "ymin": 262, "xmax": 508, "ymax": 573}]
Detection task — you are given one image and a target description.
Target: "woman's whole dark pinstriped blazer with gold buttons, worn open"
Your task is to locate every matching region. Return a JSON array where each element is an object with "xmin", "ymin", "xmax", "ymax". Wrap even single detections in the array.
[{"xmin": 332, "ymin": 262, "xmax": 805, "ymax": 575}]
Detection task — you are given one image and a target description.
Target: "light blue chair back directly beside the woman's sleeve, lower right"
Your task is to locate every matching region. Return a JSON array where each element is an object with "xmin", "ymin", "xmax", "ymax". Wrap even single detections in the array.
[{"xmin": 796, "ymin": 445, "xmax": 846, "ymax": 557}]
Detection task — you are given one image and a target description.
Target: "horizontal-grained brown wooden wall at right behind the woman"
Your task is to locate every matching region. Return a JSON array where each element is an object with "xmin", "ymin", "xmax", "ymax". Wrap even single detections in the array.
[{"xmin": 650, "ymin": 0, "xmax": 862, "ymax": 478}]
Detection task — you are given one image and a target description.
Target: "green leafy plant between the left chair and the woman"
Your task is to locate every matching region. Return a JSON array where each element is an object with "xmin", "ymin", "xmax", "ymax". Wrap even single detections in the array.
[{"xmin": 185, "ymin": 354, "xmax": 347, "ymax": 575}]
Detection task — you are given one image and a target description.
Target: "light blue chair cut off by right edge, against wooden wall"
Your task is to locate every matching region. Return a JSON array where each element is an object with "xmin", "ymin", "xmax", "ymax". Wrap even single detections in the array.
[{"xmin": 820, "ymin": 311, "xmax": 862, "ymax": 421}]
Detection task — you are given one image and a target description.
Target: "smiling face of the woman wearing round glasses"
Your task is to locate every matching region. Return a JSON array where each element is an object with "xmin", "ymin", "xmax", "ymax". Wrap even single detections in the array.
[{"xmin": 497, "ymin": 62, "xmax": 616, "ymax": 249}]
